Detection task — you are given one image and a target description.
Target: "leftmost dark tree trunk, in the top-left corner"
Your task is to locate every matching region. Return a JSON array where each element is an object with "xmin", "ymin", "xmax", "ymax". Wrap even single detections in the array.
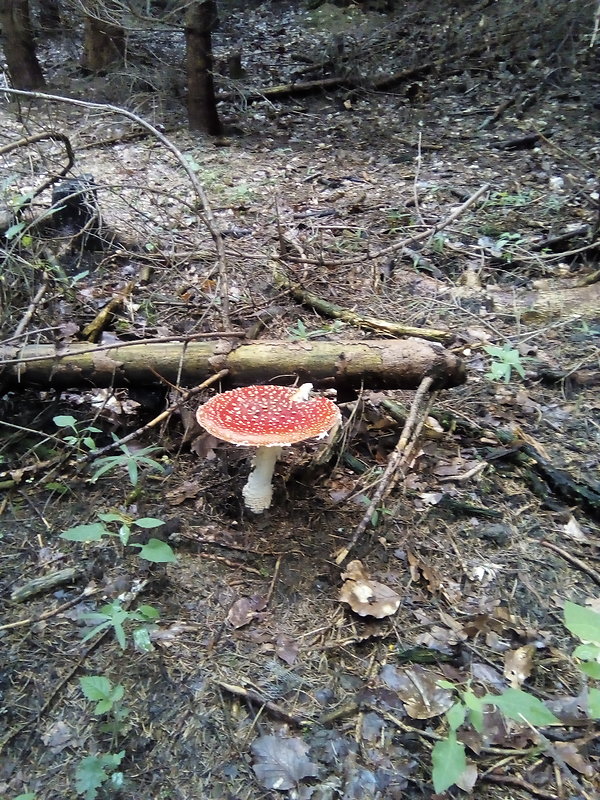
[{"xmin": 0, "ymin": 0, "xmax": 46, "ymax": 90}]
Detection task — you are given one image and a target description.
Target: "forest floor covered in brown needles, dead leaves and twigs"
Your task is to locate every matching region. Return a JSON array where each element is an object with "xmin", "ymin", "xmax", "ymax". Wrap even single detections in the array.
[{"xmin": 0, "ymin": 4, "xmax": 600, "ymax": 800}]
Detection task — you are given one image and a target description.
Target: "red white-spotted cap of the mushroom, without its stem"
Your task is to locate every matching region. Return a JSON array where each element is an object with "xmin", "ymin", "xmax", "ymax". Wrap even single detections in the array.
[{"xmin": 196, "ymin": 386, "xmax": 340, "ymax": 447}]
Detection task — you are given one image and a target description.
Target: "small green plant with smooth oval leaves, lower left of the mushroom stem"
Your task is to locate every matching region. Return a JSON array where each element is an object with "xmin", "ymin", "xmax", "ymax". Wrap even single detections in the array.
[{"xmin": 60, "ymin": 511, "xmax": 177, "ymax": 564}]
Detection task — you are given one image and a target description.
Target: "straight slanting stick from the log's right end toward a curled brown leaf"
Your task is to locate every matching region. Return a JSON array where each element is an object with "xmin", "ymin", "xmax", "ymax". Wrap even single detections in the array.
[{"xmin": 335, "ymin": 377, "xmax": 437, "ymax": 566}]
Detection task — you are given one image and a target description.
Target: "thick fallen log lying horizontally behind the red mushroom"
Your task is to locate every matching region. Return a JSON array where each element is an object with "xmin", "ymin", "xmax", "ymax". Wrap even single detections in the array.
[{"xmin": 0, "ymin": 338, "xmax": 466, "ymax": 390}]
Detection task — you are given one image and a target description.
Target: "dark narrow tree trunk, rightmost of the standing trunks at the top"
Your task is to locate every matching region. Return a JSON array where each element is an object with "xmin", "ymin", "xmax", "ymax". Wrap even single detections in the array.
[{"xmin": 185, "ymin": 0, "xmax": 223, "ymax": 136}]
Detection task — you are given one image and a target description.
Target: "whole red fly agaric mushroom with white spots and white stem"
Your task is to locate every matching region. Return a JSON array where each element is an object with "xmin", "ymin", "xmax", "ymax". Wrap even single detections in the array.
[{"xmin": 196, "ymin": 383, "xmax": 341, "ymax": 514}]
